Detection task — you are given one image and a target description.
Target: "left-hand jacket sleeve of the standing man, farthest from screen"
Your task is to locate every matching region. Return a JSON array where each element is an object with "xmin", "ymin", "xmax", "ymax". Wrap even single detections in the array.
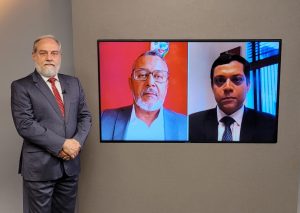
[{"xmin": 11, "ymin": 81, "xmax": 65, "ymax": 155}]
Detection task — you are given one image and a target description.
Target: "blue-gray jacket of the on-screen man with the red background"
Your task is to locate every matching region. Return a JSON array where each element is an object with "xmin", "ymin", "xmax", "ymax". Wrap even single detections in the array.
[{"xmin": 101, "ymin": 106, "xmax": 188, "ymax": 141}]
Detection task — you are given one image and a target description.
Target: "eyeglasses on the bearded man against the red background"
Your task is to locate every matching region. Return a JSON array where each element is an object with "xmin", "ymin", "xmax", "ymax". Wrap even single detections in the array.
[{"xmin": 133, "ymin": 69, "xmax": 168, "ymax": 83}]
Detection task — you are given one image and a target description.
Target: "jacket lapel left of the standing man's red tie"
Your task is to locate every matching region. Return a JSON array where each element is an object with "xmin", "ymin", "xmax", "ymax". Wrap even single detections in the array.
[{"xmin": 32, "ymin": 71, "xmax": 63, "ymax": 119}]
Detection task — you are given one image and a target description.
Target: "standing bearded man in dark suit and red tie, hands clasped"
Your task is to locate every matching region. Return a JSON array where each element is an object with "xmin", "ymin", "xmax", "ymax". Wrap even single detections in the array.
[{"xmin": 11, "ymin": 35, "xmax": 91, "ymax": 213}]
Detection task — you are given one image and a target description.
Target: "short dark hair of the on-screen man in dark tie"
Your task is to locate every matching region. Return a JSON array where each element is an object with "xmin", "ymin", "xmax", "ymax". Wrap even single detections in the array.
[{"xmin": 210, "ymin": 53, "xmax": 250, "ymax": 85}]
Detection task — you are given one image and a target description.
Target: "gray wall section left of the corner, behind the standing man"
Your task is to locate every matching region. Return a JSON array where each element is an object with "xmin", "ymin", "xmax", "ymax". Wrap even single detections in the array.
[{"xmin": 0, "ymin": 0, "xmax": 74, "ymax": 213}]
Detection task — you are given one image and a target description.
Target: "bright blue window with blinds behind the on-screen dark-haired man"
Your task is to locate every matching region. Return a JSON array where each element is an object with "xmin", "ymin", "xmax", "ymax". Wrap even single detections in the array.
[{"xmin": 246, "ymin": 41, "xmax": 279, "ymax": 115}]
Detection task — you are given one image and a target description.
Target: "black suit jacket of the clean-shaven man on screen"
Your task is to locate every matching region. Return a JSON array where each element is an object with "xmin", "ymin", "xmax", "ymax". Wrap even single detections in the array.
[{"xmin": 189, "ymin": 108, "xmax": 277, "ymax": 143}]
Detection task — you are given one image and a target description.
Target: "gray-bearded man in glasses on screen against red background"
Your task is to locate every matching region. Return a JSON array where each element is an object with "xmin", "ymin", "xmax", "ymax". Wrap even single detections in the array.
[{"xmin": 101, "ymin": 51, "xmax": 187, "ymax": 142}]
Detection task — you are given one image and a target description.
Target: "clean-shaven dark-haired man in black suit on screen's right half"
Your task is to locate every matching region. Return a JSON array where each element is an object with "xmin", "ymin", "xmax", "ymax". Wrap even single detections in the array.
[{"xmin": 189, "ymin": 53, "xmax": 277, "ymax": 143}]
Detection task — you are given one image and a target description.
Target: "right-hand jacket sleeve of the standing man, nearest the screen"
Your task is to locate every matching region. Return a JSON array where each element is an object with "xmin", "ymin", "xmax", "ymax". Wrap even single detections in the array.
[{"xmin": 73, "ymin": 79, "xmax": 92, "ymax": 146}]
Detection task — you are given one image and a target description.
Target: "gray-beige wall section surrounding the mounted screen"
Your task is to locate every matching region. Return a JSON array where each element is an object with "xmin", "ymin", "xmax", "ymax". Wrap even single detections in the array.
[{"xmin": 72, "ymin": 0, "xmax": 300, "ymax": 213}]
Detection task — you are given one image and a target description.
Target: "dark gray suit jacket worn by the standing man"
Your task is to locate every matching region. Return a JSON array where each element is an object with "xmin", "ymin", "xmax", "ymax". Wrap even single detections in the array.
[{"xmin": 11, "ymin": 71, "xmax": 91, "ymax": 181}]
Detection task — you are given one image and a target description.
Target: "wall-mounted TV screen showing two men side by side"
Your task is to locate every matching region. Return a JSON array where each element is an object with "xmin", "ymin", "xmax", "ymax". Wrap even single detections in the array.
[{"xmin": 97, "ymin": 39, "xmax": 281, "ymax": 143}]
